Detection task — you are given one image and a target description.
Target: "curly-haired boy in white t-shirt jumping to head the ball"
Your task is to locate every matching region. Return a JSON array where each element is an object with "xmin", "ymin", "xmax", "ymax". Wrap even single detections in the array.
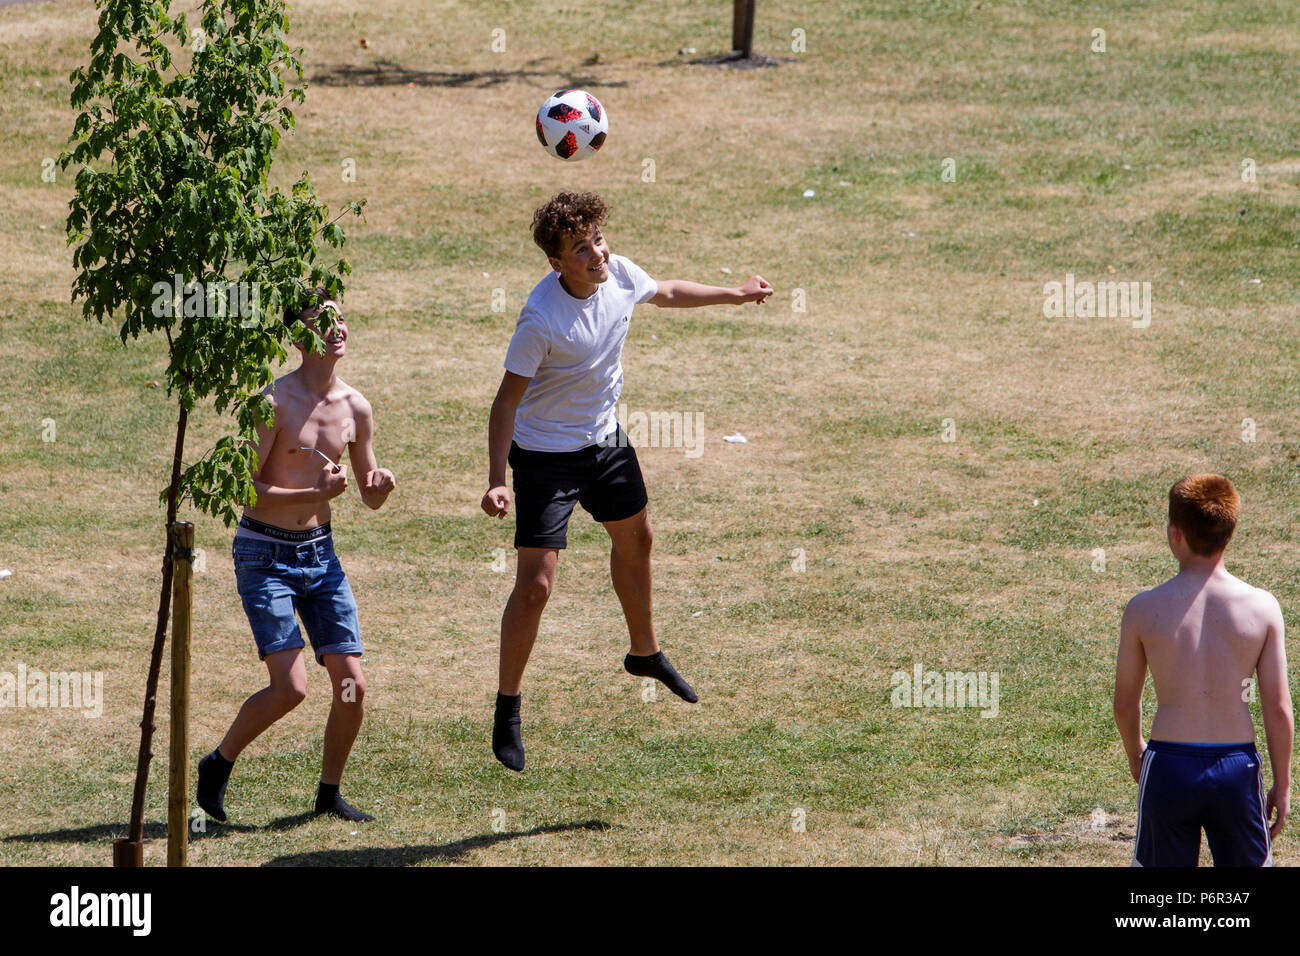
[{"xmin": 481, "ymin": 193, "xmax": 772, "ymax": 770}]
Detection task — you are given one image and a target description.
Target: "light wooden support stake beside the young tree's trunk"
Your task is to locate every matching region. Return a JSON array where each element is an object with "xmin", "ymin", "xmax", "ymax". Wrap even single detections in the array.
[{"xmin": 166, "ymin": 522, "xmax": 194, "ymax": 866}]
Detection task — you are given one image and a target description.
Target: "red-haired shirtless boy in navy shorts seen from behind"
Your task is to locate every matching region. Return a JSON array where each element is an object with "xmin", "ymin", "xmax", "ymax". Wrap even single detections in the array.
[{"xmin": 1115, "ymin": 475, "xmax": 1295, "ymax": 866}]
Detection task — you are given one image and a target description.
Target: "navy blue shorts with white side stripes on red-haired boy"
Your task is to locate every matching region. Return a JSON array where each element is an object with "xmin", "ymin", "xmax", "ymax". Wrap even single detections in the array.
[{"xmin": 1132, "ymin": 740, "xmax": 1273, "ymax": 866}]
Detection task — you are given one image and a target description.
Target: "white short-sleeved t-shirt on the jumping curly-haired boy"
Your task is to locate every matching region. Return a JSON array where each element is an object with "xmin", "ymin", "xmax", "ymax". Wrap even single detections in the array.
[{"xmin": 506, "ymin": 252, "xmax": 659, "ymax": 451}]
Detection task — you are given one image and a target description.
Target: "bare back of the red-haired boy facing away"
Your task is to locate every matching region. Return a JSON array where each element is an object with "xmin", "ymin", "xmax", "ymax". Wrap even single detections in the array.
[{"xmin": 1130, "ymin": 566, "xmax": 1277, "ymax": 744}]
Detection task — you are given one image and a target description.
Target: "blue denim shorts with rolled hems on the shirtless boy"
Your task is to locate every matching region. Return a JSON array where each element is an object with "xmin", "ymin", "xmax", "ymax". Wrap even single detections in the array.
[{"xmin": 230, "ymin": 536, "xmax": 363, "ymax": 665}]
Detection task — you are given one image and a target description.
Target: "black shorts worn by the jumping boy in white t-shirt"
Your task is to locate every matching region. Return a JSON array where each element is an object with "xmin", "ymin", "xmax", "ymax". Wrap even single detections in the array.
[{"xmin": 507, "ymin": 428, "xmax": 649, "ymax": 548}]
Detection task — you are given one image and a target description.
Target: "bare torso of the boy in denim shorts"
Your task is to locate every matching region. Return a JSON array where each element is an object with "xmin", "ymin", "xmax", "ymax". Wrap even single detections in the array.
[{"xmin": 244, "ymin": 371, "xmax": 369, "ymax": 529}]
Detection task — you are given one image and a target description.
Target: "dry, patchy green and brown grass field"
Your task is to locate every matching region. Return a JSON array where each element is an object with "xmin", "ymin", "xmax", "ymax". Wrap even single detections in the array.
[{"xmin": 0, "ymin": 0, "xmax": 1300, "ymax": 865}]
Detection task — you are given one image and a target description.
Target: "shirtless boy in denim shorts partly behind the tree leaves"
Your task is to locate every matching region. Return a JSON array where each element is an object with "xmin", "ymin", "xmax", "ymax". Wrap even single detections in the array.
[{"xmin": 199, "ymin": 289, "xmax": 395, "ymax": 822}]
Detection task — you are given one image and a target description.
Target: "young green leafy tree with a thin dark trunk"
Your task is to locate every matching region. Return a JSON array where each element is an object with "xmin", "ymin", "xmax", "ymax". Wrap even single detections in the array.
[{"xmin": 60, "ymin": 0, "xmax": 363, "ymax": 863}]
